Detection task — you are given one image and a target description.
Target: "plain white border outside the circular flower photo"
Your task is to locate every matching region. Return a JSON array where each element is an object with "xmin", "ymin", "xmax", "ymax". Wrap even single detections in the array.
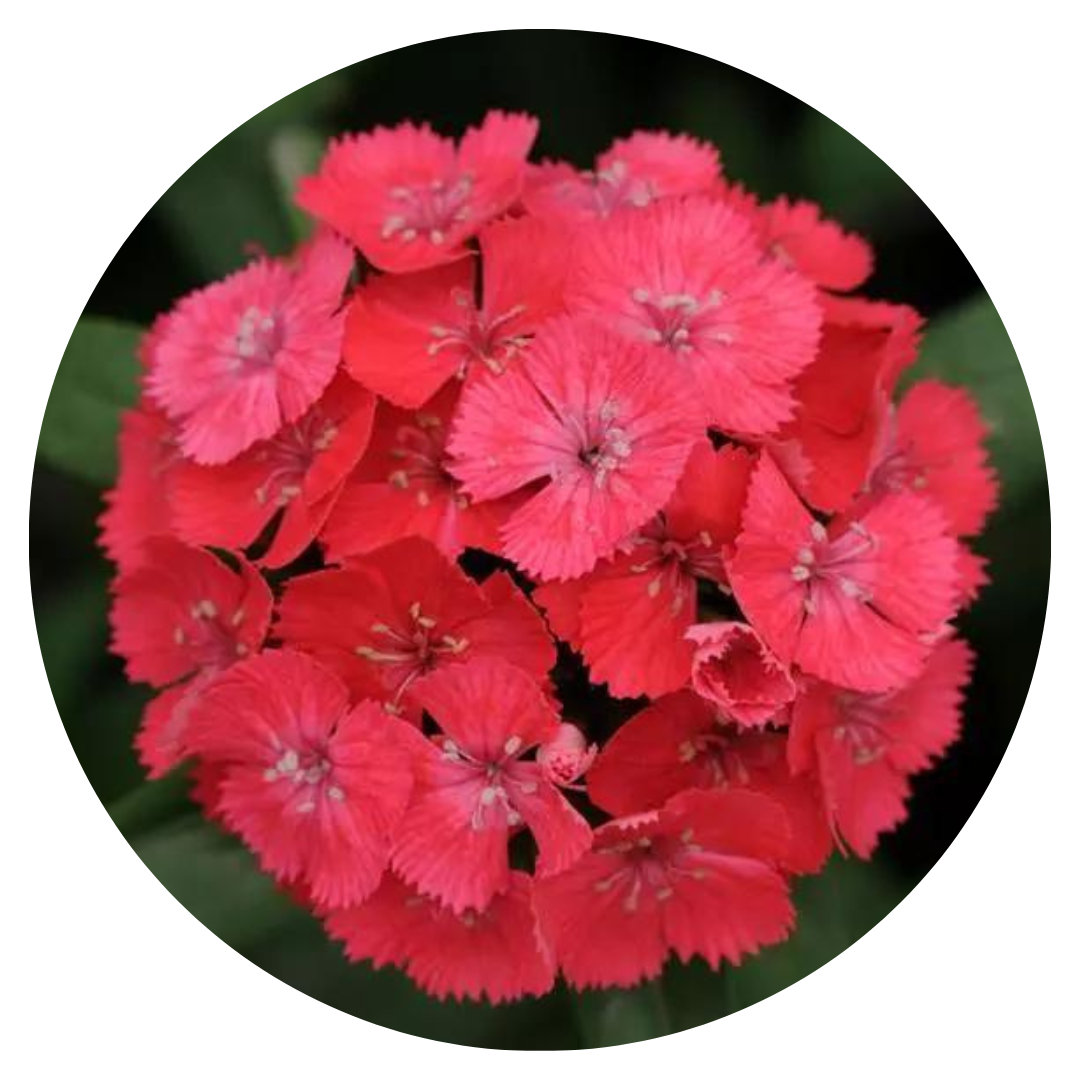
[{"xmin": 0, "ymin": 0, "xmax": 1080, "ymax": 1080}]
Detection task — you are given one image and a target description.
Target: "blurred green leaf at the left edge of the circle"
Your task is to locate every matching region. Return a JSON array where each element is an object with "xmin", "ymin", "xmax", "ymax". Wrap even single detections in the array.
[{"xmin": 38, "ymin": 316, "xmax": 143, "ymax": 487}]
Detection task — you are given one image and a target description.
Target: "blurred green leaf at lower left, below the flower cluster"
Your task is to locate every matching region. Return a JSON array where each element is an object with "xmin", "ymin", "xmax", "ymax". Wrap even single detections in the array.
[{"xmin": 132, "ymin": 815, "xmax": 297, "ymax": 948}]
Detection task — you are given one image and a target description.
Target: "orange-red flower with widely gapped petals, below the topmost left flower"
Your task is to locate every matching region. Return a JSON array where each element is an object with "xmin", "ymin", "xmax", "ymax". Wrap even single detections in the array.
[{"xmin": 345, "ymin": 217, "xmax": 566, "ymax": 408}]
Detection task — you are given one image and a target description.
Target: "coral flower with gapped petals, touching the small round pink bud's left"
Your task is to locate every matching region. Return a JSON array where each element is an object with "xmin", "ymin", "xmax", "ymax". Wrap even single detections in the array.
[{"xmin": 391, "ymin": 658, "xmax": 592, "ymax": 914}]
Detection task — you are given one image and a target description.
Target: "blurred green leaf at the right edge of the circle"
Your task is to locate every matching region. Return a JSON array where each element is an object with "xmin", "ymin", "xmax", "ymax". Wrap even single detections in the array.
[{"xmin": 906, "ymin": 293, "xmax": 1047, "ymax": 505}]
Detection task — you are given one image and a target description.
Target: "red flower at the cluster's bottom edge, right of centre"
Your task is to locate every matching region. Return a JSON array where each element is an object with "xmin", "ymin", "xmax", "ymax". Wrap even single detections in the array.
[{"xmin": 535, "ymin": 792, "xmax": 795, "ymax": 989}]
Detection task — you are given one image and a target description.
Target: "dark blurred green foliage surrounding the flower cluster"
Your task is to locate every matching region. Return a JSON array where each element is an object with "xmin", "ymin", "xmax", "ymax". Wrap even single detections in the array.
[{"xmin": 30, "ymin": 30, "xmax": 1050, "ymax": 1050}]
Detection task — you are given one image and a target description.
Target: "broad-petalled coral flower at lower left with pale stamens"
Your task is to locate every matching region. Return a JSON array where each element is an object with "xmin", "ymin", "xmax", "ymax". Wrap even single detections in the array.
[{"xmin": 188, "ymin": 649, "xmax": 413, "ymax": 906}]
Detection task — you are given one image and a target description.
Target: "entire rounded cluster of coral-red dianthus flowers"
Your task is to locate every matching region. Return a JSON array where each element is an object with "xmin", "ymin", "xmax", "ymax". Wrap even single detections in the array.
[{"xmin": 102, "ymin": 112, "xmax": 996, "ymax": 1002}]
